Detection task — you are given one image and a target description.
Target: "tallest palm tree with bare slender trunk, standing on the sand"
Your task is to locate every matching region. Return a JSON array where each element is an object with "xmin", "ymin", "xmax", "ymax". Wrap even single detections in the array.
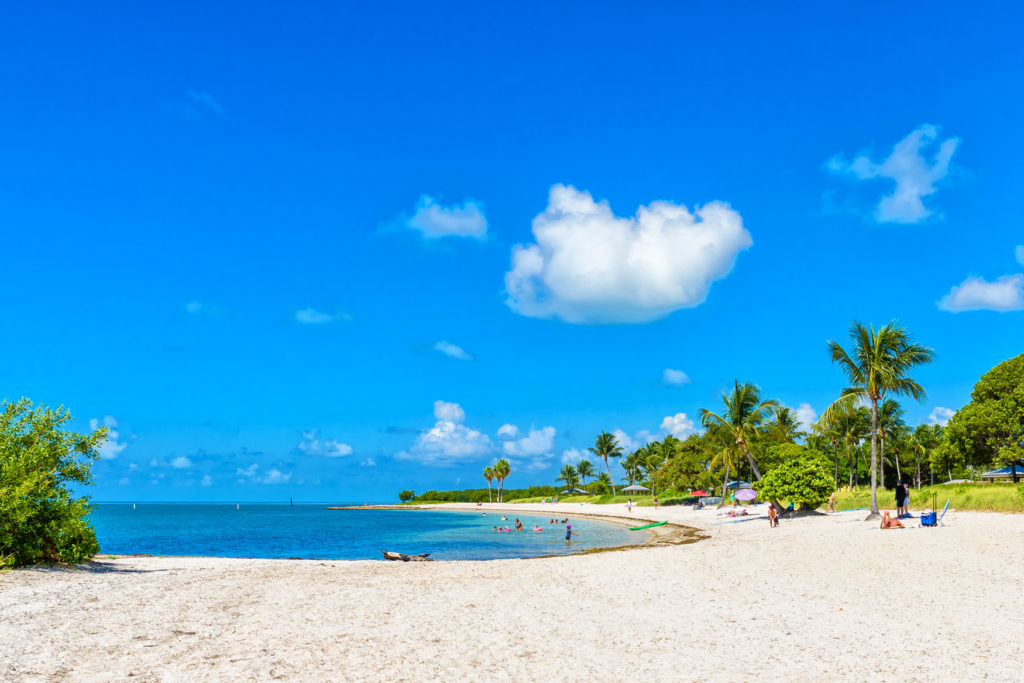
[{"xmin": 824, "ymin": 322, "xmax": 935, "ymax": 519}]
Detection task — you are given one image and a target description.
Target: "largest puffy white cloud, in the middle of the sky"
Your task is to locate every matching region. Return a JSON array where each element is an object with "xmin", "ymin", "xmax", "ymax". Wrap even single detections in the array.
[{"xmin": 505, "ymin": 184, "xmax": 753, "ymax": 324}]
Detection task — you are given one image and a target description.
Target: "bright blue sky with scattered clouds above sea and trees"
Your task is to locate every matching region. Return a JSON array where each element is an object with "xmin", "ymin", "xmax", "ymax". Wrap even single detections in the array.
[{"xmin": 0, "ymin": 2, "xmax": 1024, "ymax": 501}]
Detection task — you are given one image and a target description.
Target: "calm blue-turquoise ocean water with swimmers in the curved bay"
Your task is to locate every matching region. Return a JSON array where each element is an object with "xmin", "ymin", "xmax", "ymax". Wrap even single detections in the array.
[{"xmin": 91, "ymin": 503, "xmax": 647, "ymax": 561}]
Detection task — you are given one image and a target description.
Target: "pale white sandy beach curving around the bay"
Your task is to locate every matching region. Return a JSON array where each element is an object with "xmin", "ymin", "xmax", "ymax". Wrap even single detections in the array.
[{"xmin": 0, "ymin": 505, "xmax": 1024, "ymax": 681}]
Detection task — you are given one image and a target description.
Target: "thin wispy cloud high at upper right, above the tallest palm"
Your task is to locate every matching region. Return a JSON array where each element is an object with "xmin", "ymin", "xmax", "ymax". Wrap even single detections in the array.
[{"xmin": 826, "ymin": 124, "xmax": 959, "ymax": 223}]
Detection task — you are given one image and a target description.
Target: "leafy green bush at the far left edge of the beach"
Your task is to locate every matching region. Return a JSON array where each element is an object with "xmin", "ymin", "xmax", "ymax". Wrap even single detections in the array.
[{"xmin": 0, "ymin": 398, "xmax": 106, "ymax": 566}]
